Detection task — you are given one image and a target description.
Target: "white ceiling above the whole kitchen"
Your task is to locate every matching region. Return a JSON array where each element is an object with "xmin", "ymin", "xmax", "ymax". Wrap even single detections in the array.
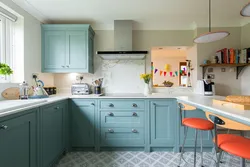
[{"xmin": 12, "ymin": 0, "xmax": 250, "ymax": 30}]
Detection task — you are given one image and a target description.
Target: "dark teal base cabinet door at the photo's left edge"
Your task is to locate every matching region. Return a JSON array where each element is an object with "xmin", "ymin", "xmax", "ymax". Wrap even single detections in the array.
[{"xmin": 0, "ymin": 110, "xmax": 37, "ymax": 167}]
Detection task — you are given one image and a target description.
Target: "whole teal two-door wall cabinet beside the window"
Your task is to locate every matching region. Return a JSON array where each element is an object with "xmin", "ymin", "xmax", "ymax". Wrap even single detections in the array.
[{"xmin": 42, "ymin": 24, "xmax": 95, "ymax": 73}]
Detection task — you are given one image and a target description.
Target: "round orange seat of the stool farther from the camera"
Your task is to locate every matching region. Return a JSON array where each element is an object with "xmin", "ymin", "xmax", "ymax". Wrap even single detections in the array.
[{"xmin": 182, "ymin": 118, "xmax": 214, "ymax": 130}]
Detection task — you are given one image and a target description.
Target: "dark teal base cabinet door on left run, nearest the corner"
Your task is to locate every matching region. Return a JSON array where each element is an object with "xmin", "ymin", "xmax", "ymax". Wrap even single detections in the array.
[{"xmin": 40, "ymin": 102, "xmax": 68, "ymax": 167}]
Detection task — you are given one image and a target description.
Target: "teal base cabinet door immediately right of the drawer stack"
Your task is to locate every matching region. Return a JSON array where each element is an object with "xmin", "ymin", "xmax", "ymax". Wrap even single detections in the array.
[{"xmin": 150, "ymin": 100, "xmax": 177, "ymax": 147}]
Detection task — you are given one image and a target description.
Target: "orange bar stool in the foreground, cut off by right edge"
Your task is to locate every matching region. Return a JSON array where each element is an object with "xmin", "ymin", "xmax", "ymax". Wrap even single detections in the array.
[{"xmin": 206, "ymin": 112, "xmax": 250, "ymax": 167}]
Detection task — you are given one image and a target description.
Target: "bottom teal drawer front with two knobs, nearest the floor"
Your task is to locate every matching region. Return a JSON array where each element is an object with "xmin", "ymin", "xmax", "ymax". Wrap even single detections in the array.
[{"xmin": 101, "ymin": 128, "xmax": 144, "ymax": 147}]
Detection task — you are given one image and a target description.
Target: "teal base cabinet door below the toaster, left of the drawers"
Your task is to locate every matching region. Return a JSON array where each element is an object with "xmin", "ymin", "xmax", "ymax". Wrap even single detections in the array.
[{"xmin": 71, "ymin": 101, "xmax": 95, "ymax": 148}]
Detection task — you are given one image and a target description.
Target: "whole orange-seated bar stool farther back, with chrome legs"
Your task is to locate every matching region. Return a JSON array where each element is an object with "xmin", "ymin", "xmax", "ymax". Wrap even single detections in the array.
[{"xmin": 178, "ymin": 103, "xmax": 214, "ymax": 167}]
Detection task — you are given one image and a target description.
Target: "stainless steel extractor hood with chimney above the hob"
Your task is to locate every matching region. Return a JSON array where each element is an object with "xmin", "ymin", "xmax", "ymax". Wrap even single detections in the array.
[{"xmin": 97, "ymin": 20, "xmax": 148, "ymax": 60}]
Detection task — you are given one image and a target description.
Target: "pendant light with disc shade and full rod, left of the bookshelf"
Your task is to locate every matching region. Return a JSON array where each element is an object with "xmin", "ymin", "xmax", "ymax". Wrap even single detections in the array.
[{"xmin": 194, "ymin": 0, "xmax": 230, "ymax": 44}]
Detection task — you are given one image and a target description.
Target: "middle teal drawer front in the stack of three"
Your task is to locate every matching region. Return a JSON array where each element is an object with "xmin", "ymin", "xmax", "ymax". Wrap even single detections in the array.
[{"xmin": 101, "ymin": 111, "xmax": 144, "ymax": 127}]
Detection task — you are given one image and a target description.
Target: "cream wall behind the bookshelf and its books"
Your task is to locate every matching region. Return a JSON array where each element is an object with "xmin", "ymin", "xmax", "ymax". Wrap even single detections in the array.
[{"xmin": 196, "ymin": 27, "xmax": 241, "ymax": 96}]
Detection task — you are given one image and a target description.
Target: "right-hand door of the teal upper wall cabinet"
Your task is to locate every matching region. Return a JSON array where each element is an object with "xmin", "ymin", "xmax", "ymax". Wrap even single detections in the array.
[{"xmin": 66, "ymin": 30, "xmax": 88, "ymax": 72}]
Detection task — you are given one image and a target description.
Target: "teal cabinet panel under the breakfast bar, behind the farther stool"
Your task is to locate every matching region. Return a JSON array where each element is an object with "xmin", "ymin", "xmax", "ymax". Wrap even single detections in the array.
[{"xmin": 178, "ymin": 109, "xmax": 213, "ymax": 151}]
